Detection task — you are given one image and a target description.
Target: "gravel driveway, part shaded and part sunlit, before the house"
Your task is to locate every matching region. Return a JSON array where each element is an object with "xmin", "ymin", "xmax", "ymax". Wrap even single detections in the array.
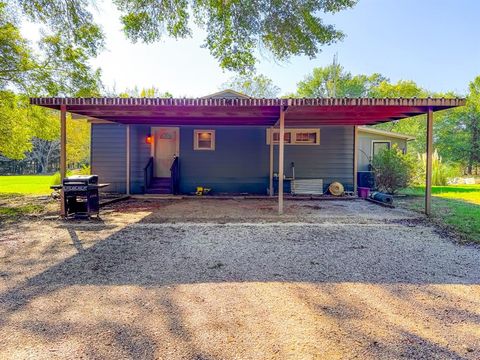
[{"xmin": 0, "ymin": 199, "xmax": 480, "ymax": 359}]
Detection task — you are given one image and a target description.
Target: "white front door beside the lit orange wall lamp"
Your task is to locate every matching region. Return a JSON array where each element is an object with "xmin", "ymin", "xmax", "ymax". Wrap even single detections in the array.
[{"xmin": 153, "ymin": 127, "xmax": 180, "ymax": 177}]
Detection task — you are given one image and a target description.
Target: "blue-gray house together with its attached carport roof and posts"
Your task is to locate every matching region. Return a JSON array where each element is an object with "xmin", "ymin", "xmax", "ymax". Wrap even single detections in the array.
[{"xmin": 31, "ymin": 90, "xmax": 464, "ymax": 212}]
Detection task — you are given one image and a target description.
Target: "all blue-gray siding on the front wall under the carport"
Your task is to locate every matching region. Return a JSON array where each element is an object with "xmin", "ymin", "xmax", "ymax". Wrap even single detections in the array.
[{"xmin": 92, "ymin": 124, "xmax": 353, "ymax": 194}]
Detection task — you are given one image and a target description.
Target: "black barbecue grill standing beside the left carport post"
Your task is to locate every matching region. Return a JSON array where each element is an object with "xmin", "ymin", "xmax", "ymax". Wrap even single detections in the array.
[{"xmin": 51, "ymin": 175, "xmax": 108, "ymax": 217}]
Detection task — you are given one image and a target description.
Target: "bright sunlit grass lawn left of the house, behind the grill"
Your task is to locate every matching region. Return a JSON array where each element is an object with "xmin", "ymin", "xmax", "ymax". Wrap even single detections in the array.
[{"xmin": 0, "ymin": 175, "xmax": 54, "ymax": 195}]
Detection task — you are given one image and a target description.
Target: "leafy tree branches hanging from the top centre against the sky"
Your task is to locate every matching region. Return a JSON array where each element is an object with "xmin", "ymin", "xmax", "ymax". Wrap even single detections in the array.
[{"xmin": 114, "ymin": 0, "xmax": 357, "ymax": 73}]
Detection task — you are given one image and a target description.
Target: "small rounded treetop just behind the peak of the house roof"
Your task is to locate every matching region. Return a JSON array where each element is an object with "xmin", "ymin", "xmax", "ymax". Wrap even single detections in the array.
[{"xmin": 222, "ymin": 75, "xmax": 280, "ymax": 98}]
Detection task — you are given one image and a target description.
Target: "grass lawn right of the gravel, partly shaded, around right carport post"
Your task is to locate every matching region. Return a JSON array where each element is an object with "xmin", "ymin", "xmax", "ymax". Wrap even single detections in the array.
[{"xmin": 399, "ymin": 184, "xmax": 480, "ymax": 243}]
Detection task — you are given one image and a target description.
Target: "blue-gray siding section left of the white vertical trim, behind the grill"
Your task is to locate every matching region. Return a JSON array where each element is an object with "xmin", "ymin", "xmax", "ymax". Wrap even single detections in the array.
[{"xmin": 91, "ymin": 124, "xmax": 126, "ymax": 193}]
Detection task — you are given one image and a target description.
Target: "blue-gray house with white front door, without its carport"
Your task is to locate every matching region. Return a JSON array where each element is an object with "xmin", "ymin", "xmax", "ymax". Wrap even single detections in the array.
[{"xmin": 91, "ymin": 90, "xmax": 413, "ymax": 195}]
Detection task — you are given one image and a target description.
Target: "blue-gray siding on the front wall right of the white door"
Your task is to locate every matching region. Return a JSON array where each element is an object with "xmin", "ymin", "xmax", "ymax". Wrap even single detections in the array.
[{"xmin": 180, "ymin": 126, "xmax": 353, "ymax": 194}]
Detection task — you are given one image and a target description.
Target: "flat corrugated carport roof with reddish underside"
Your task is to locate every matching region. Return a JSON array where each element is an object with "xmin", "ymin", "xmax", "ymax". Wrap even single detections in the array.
[{"xmin": 30, "ymin": 98, "xmax": 465, "ymax": 126}]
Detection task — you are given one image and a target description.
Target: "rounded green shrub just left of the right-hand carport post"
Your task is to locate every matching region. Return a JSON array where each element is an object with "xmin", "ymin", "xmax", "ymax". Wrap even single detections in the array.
[{"xmin": 372, "ymin": 145, "xmax": 415, "ymax": 194}]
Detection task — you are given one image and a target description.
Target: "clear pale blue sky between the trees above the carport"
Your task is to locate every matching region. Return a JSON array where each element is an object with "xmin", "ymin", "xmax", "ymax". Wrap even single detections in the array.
[{"xmin": 53, "ymin": 0, "xmax": 480, "ymax": 96}]
